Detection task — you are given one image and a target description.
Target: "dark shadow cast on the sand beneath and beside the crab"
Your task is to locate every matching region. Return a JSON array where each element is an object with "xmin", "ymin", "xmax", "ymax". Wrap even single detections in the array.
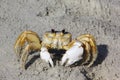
[{"xmin": 25, "ymin": 44, "xmax": 108, "ymax": 69}]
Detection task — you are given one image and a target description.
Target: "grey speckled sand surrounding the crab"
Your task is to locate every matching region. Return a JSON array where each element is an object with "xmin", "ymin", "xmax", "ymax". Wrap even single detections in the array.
[{"xmin": 0, "ymin": 0, "xmax": 120, "ymax": 80}]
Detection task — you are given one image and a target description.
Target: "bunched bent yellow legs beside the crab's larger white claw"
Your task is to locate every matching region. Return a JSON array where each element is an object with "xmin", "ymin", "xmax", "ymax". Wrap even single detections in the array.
[{"xmin": 77, "ymin": 34, "xmax": 98, "ymax": 67}]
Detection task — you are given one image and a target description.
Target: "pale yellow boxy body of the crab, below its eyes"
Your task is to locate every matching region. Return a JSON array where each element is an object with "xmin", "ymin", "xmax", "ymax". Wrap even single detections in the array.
[{"xmin": 42, "ymin": 32, "xmax": 71, "ymax": 49}]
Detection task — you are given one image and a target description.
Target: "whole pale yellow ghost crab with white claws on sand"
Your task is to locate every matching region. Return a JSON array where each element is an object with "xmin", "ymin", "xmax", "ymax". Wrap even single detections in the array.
[{"xmin": 14, "ymin": 29, "xmax": 98, "ymax": 69}]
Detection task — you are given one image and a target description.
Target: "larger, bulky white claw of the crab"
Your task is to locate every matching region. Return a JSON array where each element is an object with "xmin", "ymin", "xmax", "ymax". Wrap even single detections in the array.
[{"xmin": 61, "ymin": 42, "xmax": 84, "ymax": 66}]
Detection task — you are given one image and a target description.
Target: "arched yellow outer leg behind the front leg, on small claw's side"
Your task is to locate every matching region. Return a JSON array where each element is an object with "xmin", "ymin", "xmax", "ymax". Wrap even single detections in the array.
[{"xmin": 14, "ymin": 31, "xmax": 41, "ymax": 58}]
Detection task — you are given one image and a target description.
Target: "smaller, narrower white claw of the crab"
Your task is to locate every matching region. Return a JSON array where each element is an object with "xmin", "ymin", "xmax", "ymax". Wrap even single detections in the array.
[{"xmin": 40, "ymin": 47, "xmax": 54, "ymax": 67}]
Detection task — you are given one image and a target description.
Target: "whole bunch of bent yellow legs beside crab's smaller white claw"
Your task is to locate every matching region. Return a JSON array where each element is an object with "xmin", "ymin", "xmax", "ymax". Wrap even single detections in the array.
[{"xmin": 14, "ymin": 31, "xmax": 41, "ymax": 68}]
